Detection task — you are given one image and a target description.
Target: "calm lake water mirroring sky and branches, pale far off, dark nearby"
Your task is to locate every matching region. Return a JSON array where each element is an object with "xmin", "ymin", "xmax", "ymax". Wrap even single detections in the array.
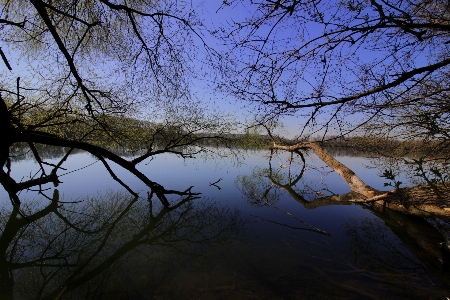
[{"xmin": 0, "ymin": 147, "xmax": 450, "ymax": 299}]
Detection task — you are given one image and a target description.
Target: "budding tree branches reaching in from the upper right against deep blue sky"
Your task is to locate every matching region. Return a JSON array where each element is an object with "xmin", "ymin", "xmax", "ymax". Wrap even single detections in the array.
[{"xmin": 219, "ymin": 0, "xmax": 450, "ymax": 149}]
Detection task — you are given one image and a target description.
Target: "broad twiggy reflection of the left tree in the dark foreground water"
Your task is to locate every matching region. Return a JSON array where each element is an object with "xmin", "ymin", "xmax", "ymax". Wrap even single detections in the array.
[{"xmin": 0, "ymin": 192, "xmax": 242, "ymax": 299}]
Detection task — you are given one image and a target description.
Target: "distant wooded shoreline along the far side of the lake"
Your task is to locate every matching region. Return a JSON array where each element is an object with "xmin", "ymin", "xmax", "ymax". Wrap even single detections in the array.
[{"xmin": 13, "ymin": 102, "xmax": 450, "ymax": 159}]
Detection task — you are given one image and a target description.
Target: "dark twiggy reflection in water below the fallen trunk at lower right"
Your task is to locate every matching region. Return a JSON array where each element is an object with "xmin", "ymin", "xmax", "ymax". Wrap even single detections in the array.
[{"xmin": 345, "ymin": 212, "xmax": 450, "ymax": 299}]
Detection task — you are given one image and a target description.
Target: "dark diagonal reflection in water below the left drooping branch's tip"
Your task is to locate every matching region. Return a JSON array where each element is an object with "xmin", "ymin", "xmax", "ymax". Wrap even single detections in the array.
[{"xmin": 36, "ymin": 193, "xmax": 227, "ymax": 299}]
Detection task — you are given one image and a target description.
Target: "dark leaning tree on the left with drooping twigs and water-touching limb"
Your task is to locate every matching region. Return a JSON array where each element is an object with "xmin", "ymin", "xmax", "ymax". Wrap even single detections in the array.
[{"xmin": 0, "ymin": 0, "xmax": 231, "ymax": 208}]
